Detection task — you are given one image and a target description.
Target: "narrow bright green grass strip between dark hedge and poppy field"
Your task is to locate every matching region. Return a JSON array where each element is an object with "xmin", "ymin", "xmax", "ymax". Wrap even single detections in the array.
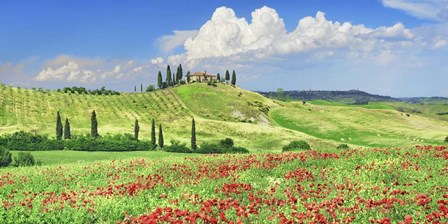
[{"xmin": 11, "ymin": 151, "xmax": 198, "ymax": 165}]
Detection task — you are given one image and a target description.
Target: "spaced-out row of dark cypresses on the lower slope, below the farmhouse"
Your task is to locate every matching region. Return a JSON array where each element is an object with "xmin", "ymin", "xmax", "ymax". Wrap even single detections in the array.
[{"xmin": 56, "ymin": 110, "xmax": 197, "ymax": 150}]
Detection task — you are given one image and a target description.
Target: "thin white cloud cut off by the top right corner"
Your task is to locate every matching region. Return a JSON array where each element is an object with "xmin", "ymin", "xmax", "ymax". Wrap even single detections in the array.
[{"xmin": 383, "ymin": 0, "xmax": 448, "ymax": 21}]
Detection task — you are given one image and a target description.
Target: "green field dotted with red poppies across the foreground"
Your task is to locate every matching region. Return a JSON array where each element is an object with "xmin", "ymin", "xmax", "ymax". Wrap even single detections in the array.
[{"xmin": 0, "ymin": 146, "xmax": 448, "ymax": 223}]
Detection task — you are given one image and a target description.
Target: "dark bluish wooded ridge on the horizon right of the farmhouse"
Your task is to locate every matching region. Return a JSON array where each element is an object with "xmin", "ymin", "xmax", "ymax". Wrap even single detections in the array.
[{"xmin": 258, "ymin": 90, "xmax": 401, "ymax": 104}]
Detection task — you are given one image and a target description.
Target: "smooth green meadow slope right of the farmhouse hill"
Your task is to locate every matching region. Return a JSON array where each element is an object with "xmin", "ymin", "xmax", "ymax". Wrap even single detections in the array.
[{"xmin": 271, "ymin": 103, "xmax": 448, "ymax": 146}]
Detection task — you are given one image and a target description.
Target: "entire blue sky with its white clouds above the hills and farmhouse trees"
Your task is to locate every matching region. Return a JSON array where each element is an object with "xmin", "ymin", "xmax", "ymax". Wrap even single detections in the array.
[{"xmin": 0, "ymin": 0, "xmax": 448, "ymax": 96}]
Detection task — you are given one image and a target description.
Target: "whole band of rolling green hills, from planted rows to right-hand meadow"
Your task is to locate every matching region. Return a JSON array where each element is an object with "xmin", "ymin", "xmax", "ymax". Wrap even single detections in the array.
[{"xmin": 0, "ymin": 83, "xmax": 448, "ymax": 150}]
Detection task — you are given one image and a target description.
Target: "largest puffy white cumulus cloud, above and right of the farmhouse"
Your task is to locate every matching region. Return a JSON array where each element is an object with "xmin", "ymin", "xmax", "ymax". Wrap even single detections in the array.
[{"xmin": 169, "ymin": 6, "xmax": 415, "ymax": 67}]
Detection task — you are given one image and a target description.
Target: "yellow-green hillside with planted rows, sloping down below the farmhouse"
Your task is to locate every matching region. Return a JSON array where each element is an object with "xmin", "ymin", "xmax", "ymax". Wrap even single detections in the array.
[{"xmin": 0, "ymin": 83, "xmax": 336, "ymax": 150}]
